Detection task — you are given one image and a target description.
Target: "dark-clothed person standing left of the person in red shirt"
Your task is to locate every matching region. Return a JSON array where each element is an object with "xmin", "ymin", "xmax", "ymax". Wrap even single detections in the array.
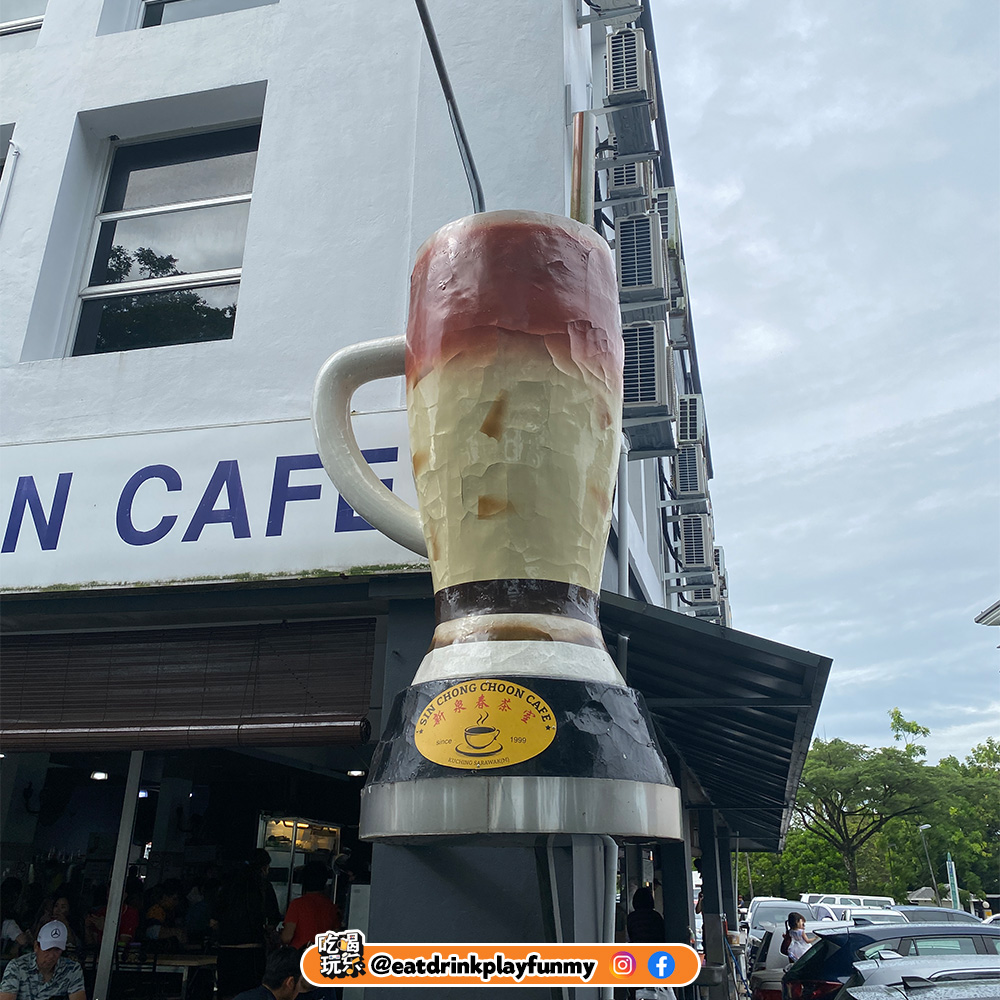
[{"xmin": 216, "ymin": 849, "xmax": 281, "ymax": 998}]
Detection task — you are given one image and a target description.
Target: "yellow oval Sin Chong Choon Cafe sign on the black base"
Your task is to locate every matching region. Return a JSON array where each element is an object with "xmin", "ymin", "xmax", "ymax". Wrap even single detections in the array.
[{"xmin": 413, "ymin": 677, "xmax": 556, "ymax": 770}]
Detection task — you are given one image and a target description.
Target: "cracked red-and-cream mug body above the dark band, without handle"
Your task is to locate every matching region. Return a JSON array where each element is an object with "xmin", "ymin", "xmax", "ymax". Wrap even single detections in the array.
[{"xmin": 406, "ymin": 212, "xmax": 623, "ymax": 591}]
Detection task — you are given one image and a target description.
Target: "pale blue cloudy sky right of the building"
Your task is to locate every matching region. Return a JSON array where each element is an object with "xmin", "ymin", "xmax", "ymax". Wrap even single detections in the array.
[{"xmin": 651, "ymin": 0, "xmax": 1000, "ymax": 759}]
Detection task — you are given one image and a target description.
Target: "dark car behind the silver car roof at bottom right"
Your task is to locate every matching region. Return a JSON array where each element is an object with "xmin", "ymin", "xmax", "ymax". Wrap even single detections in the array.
[{"xmin": 781, "ymin": 923, "xmax": 1000, "ymax": 1000}]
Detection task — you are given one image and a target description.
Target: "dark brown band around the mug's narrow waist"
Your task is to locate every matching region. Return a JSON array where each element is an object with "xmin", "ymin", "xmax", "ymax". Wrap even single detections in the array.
[{"xmin": 434, "ymin": 579, "xmax": 600, "ymax": 626}]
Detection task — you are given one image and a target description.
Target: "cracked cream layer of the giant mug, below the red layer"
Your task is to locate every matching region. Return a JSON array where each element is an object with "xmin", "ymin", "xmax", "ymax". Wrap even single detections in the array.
[{"xmin": 407, "ymin": 333, "xmax": 621, "ymax": 591}]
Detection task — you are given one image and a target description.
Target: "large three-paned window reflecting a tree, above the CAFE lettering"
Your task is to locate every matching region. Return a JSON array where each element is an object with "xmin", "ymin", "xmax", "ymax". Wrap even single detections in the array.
[{"xmin": 73, "ymin": 125, "xmax": 260, "ymax": 355}]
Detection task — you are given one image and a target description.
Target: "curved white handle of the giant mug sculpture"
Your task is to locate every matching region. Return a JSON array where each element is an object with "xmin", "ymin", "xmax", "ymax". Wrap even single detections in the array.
[{"xmin": 312, "ymin": 337, "xmax": 427, "ymax": 556}]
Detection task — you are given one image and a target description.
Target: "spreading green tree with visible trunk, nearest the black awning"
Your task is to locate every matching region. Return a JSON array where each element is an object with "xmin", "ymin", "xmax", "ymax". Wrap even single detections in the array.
[{"xmin": 795, "ymin": 709, "xmax": 937, "ymax": 892}]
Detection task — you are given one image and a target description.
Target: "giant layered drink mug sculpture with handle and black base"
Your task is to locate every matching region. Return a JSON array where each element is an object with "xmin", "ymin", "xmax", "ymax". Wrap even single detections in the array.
[{"xmin": 314, "ymin": 212, "xmax": 681, "ymax": 840}]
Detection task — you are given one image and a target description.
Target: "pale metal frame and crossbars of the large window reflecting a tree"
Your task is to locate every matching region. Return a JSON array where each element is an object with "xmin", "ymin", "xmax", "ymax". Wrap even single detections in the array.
[{"xmin": 68, "ymin": 120, "xmax": 261, "ymax": 357}]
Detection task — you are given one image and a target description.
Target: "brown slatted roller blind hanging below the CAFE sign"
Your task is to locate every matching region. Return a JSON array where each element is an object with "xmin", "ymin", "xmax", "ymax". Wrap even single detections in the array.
[{"xmin": 0, "ymin": 618, "xmax": 375, "ymax": 751}]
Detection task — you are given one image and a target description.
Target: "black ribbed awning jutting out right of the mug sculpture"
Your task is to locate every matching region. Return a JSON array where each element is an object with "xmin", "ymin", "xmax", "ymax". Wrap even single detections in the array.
[{"xmin": 601, "ymin": 593, "xmax": 832, "ymax": 851}]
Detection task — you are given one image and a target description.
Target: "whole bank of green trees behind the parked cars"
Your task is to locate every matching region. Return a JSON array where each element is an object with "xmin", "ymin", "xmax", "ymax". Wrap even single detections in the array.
[{"xmin": 738, "ymin": 709, "xmax": 1000, "ymax": 902}]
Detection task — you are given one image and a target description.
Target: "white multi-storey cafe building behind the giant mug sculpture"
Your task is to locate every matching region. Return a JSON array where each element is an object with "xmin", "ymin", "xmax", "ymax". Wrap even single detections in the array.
[{"xmin": 0, "ymin": 0, "xmax": 829, "ymax": 992}]
